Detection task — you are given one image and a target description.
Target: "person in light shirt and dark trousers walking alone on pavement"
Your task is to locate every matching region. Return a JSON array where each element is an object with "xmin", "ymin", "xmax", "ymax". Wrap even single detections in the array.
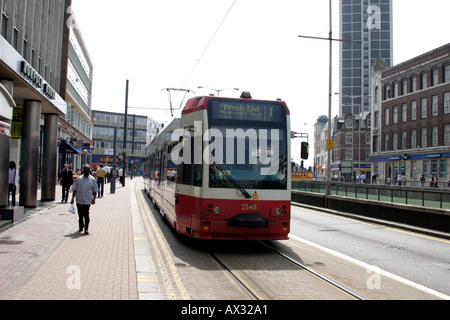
[{"xmin": 70, "ymin": 165, "xmax": 98, "ymax": 234}]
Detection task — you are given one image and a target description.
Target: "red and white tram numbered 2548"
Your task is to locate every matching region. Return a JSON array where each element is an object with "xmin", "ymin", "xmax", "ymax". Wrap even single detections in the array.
[{"xmin": 144, "ymin": 93, "xmax": 291, "ymax": 240}]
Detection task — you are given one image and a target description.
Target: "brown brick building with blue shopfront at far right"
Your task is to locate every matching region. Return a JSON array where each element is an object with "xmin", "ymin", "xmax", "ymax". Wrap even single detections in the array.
[{"xmin": 371, "ymin": 44, "xmax": 450, "ymax": 186}]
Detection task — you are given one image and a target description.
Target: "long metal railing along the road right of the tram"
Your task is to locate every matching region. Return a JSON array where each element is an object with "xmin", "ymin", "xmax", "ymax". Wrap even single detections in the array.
[{"xmin": 292, "ymin": 181, "xmax": 450, "ymax": 210}]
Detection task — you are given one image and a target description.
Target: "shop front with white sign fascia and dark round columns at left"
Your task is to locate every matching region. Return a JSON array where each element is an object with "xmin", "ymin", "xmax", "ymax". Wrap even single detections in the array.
[{"xmin": 0, "ymin": 37, "xmax": 67, "ymax": 208}]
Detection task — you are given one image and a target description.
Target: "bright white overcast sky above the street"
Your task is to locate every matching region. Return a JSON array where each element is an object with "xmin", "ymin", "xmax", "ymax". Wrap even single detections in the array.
[{"xmin": 72, "ymin": 0, "xmax": 450, "ymax": 166}]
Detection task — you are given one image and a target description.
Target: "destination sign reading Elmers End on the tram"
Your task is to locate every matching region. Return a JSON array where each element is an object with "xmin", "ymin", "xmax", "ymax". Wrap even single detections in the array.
[{"xmin": 212, "ymin": 101, "xmax": 284, "ymax": 122}]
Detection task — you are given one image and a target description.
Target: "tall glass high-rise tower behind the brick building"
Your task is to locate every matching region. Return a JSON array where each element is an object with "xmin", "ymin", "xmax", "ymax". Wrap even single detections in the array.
[{"xmin": 339, "ymin": 0, "xmax": 393, "ymax": 117}]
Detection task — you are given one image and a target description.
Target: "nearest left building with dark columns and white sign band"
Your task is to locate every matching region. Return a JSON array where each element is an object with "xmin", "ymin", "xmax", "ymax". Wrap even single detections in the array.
[{"xmin": 0, "ymin": 0, "xmax": 71, "ymax": 207}]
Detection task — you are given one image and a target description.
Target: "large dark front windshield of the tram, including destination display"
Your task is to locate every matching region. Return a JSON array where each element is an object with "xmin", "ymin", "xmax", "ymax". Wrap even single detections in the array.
[{"xmin": 208, "ymin": 99, "xmax": 288, "ymax": 190}]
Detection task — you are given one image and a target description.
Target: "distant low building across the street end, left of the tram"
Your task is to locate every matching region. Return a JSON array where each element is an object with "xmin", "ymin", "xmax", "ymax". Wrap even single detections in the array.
[{"xmin": 92, "ymin": 110, "xmax": 160, "ymax": 175}]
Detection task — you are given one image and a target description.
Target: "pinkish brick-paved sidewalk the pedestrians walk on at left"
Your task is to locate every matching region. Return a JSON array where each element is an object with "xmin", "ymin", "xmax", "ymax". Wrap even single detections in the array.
[{"xmin": 0, "ymin": 180, "xmax": 139, "ymax": 300}]
